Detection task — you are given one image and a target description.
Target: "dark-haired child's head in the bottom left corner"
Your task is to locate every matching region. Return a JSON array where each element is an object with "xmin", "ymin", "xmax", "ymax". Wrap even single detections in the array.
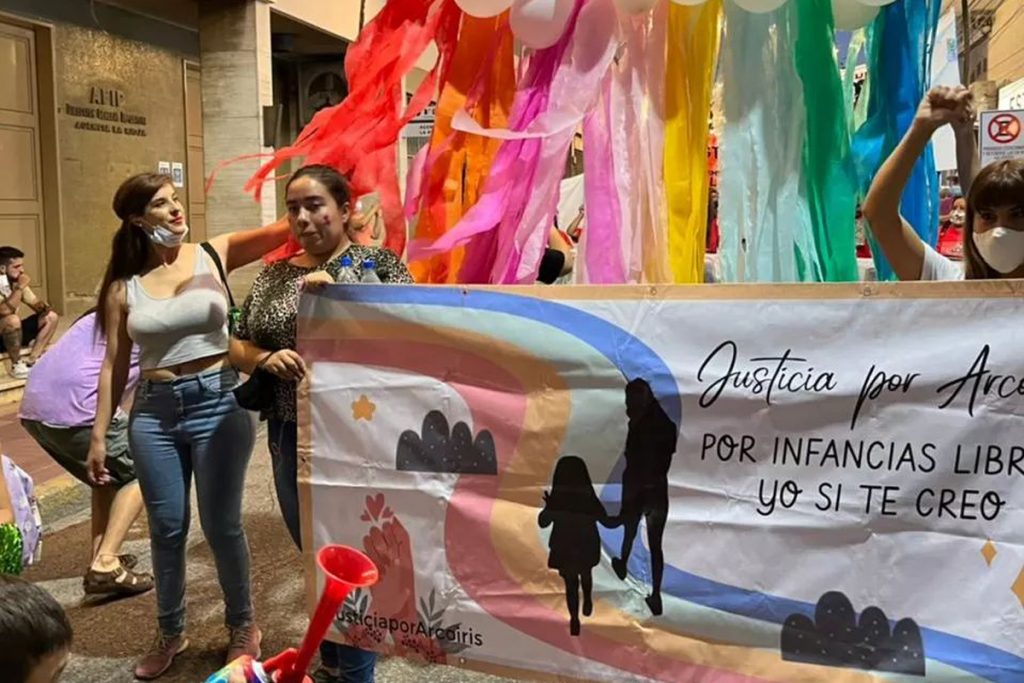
[{"xmin": 0, "ymin": 575, "xmax": 72, "ymax": 683}]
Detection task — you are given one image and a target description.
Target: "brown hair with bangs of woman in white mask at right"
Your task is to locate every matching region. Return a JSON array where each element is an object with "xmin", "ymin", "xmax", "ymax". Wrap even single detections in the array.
[{"xmin": 964, "ymin": 159, "xmax": 1024, "ymax": 280}]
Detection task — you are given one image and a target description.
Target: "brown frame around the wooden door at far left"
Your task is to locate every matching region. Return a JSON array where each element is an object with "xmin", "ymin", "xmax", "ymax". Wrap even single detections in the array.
[{"xmin": 0, "ymin": 11, "xmax": 68, "ymax": 314}]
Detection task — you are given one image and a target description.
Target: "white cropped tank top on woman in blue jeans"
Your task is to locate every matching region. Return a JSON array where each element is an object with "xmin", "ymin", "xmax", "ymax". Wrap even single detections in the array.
[{"xmin": 126, "ymin": 249, "xmax": 228, "ymax": 370}]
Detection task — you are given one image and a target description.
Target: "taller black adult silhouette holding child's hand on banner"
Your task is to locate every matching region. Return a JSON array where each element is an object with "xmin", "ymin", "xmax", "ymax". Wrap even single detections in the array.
[{"xmin": 611, "ymin": 379, "xmax": 679, "ymax": 616}]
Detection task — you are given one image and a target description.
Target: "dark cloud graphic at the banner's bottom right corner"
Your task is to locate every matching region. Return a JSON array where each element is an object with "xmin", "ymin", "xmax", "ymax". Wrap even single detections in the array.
[{"xmin": 781, "ymin": 592, "xmax": 925, "ymax": 676}]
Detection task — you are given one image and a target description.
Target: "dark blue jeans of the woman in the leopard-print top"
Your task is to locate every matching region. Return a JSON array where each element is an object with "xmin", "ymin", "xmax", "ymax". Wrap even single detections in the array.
[{"xmin": 267, "ymin": 420, "xmax": 377, "ymax": 683}]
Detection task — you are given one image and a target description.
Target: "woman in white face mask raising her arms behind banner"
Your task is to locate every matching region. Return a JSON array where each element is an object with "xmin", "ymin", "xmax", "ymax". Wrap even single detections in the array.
[{"xmin": 864, "ymin": 88, "xmax": 1024, "ymax": 281}]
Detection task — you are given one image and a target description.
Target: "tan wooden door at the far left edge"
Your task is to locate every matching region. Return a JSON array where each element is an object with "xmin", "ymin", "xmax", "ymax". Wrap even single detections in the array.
[{"xmin": 0, "ymin": 23, "xmax": 47, "ymax": 300}]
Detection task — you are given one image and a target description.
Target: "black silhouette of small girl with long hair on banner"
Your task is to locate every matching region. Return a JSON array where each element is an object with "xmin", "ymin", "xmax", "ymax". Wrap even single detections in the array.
[{"xmin": 538, "ymin": 456, "xmax": 615, "ymax": 636}]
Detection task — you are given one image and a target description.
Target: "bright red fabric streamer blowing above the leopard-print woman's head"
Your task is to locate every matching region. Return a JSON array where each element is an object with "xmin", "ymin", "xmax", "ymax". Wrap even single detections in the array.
[{"xmin": 246, "ymin": 0, "xmax": 462, "ymax": 262}]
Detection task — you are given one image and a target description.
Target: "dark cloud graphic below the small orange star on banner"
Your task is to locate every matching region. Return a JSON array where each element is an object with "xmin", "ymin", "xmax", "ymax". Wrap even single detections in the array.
[{"xmin": 396, "ymin": 411, "xmax": 498, "ymax": 475}]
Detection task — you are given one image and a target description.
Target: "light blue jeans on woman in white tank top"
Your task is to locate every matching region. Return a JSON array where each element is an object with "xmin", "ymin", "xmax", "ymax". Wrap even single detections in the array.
[{"xmin": 129, "ymin": 369, "xmax": 256, "ymax": 636}]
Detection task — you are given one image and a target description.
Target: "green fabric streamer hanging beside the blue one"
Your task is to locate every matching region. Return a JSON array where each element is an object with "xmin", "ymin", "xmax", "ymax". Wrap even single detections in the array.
[{"xmin": 791, "ymin": 0, "xmax": 859, "ymax": 283}]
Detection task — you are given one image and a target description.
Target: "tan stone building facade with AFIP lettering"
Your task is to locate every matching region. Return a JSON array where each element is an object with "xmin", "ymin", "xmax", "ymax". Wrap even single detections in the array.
[{"xmin": 0, "ymin": 0, "xmax": 411, "ymax": 314}]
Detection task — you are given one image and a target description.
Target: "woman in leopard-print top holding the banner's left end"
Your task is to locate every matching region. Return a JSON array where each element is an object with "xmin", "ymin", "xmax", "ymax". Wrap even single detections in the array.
[{"xmin": 231, "ymin": 165, "xmax": 413, "ymax": 683}]
